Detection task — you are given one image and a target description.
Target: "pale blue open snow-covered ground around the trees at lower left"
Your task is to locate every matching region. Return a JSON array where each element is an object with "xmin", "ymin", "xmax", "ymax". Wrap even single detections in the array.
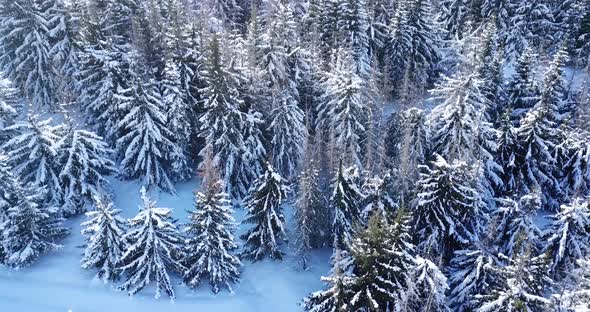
[{"xmin": 0, "ymin": 180, "xmax": 330, "ymax": 312}]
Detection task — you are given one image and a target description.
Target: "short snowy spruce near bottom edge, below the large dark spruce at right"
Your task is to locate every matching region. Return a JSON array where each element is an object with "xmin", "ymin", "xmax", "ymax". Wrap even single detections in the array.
[{"xmin": 449, "ymin": 244, "xmax": 499, "ymax": 312}]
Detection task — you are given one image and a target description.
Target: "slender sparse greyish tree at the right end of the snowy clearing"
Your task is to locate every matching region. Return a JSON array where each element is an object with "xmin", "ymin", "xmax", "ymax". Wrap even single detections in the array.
[{"xmin": 295, "ymin": 151, "xmax": 331, "ymax": 269}]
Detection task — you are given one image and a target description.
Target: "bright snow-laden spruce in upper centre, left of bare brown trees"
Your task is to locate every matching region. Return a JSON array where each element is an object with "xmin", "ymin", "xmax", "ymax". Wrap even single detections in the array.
[{"xmin": 318, "ymin": 49, "xmax": 370, "ymax": 167}]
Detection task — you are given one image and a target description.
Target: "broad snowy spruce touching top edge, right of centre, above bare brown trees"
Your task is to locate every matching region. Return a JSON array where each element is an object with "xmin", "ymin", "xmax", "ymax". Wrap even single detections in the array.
[{"xmin": 386, "ymin": 0, "xmax": 441, "ymax": 98}]
